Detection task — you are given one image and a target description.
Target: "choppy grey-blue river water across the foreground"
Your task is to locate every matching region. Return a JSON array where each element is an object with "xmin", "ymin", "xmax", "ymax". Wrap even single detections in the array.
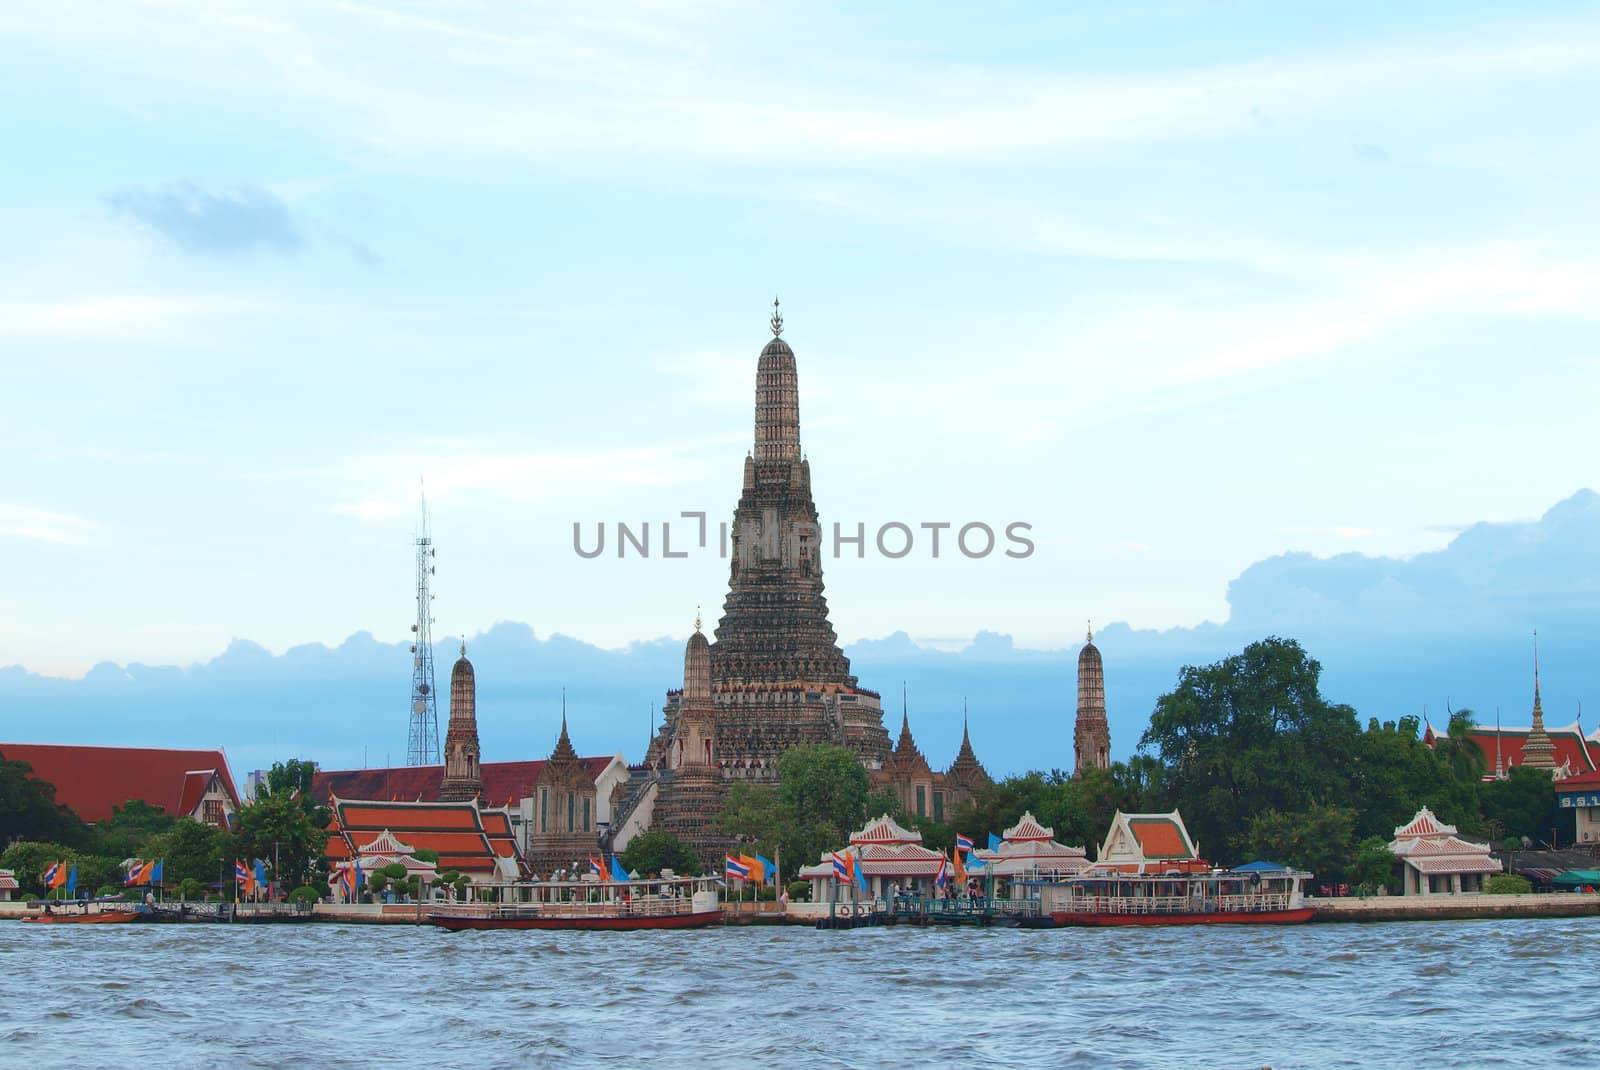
[{"xmin": 0, "ymin": 918, "xmax": 1600, "ymax": 1070}]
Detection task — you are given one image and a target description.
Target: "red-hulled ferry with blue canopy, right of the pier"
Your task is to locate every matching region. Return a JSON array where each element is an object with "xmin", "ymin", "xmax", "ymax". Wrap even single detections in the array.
[{"xmin": 1018, "ymin": 862, "xmax": 1317, "ymax": 926}]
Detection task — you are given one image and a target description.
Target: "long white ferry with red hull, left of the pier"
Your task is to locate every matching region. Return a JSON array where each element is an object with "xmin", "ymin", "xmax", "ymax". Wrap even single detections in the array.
[{"xmin": 427, "ymin": 876, "xmax": 722, "ymax": 932}]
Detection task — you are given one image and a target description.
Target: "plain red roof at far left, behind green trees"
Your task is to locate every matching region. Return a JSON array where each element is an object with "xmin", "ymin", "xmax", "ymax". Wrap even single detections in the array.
[{"xmin": 0, "ymin": 744, "xmax": 238, "ymax": 820}]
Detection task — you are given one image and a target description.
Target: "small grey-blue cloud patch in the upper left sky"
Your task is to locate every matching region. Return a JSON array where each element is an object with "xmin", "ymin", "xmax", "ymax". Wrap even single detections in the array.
[{"xmin": 107, "ymin": 182, "xmax": 301, "ymax": 256}]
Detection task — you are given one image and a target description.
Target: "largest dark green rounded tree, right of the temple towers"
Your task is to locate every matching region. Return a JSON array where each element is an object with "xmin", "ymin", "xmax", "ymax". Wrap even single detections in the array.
[{"xmin": 1139, "ymin": 637, "xmax": 1360, "ymax": 860}]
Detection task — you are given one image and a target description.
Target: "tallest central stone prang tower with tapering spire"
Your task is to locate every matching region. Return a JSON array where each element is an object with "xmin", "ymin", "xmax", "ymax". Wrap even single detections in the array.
[{"xmin": 710, "ymin": 301, "xmax": 890, "ymax": 779}]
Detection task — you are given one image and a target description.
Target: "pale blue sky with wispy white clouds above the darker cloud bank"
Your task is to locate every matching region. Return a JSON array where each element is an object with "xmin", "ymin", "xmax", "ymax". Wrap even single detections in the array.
[{"xmin": 0, "ymin": 0, "xmax": 1600, "ymax": 687}]
